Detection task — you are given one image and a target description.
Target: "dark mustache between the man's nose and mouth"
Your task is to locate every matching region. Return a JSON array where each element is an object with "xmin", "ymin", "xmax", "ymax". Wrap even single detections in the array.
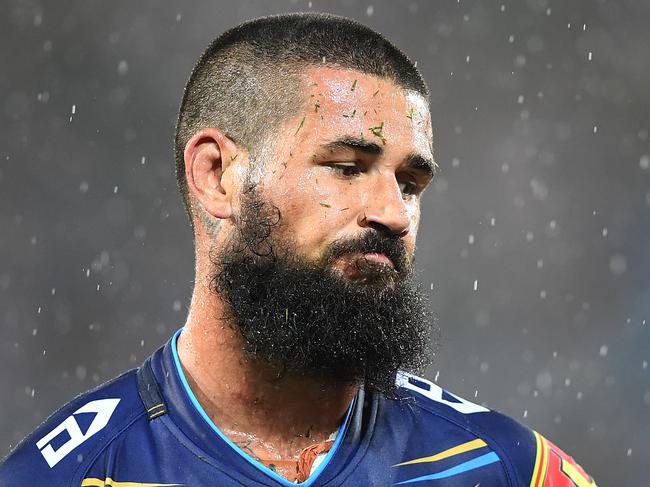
[{"xmin": 323, "ymin": 230, "xmax": 414, "ymax": 274}]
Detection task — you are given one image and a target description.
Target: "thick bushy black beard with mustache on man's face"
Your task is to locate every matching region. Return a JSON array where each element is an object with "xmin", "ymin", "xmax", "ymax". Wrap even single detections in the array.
[{"xmin": 211, "ymin": 183, "xmax": 433, "ymax": 396}]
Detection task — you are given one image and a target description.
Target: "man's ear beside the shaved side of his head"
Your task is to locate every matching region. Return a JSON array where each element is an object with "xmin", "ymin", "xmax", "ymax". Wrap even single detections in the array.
[{"xmin": 184, "ymin": 128, "xmax": 238, "ymax": 219}]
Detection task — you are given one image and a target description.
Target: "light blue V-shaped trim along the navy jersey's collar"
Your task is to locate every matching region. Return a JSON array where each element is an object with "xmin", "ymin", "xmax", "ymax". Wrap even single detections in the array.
[{"xmin": 171, "ymin": 328, "xmax": 356, "ymax": 487}]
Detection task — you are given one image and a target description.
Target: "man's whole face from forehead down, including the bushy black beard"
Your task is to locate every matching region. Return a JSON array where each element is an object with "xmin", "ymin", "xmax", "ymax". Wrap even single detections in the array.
[{"xmin": 212, "ymin": 68, "xmax": 433, "ymax": 392}]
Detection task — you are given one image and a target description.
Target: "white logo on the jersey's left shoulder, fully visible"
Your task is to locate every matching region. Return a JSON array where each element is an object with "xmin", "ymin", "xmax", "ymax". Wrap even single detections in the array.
[{"xmin": 36, "ymin": 399, "xmax": 120, "ymax": 468}]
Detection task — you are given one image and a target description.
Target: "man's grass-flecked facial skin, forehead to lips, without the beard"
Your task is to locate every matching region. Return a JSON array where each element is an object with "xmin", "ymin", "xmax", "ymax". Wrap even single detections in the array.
[{"xmin": 240, "ymin": 67, "xmax": 434, "ymax": 279}]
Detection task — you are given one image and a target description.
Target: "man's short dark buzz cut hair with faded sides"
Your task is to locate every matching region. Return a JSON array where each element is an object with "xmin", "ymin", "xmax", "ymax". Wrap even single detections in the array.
[{"xmin": 174, "ymin": 12, "xmax": 429, "ymax": 233}]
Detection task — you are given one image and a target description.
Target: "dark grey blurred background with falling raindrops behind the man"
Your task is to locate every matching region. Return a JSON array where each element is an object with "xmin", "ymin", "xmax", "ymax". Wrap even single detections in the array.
[{"xmin": 0, "ymin": 0, "xmax": 650, "ymax": 487}]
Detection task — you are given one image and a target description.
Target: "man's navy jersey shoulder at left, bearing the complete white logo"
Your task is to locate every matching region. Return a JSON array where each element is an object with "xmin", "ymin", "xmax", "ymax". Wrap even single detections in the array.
[{"xmin": 0, "ymin": 370, "xmax": 145, "ymax": 487}]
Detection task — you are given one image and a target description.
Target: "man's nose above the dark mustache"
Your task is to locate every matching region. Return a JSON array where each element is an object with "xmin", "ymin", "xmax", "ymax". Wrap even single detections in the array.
[{"xmin": 357, "ymin": 175, "xmax": 411, "ymax": 237}]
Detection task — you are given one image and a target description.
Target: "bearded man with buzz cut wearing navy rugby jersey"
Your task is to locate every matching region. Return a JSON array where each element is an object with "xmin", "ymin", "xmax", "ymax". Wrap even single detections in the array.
[{"xmin": 0, "ymin": 14, "xmax": 595, "ymax": 487}]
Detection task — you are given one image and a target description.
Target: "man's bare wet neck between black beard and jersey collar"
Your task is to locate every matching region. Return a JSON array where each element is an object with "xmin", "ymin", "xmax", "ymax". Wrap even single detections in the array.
[{"xmin": 178, "ymin": 289, "xmax": 357, "ymax": 470}]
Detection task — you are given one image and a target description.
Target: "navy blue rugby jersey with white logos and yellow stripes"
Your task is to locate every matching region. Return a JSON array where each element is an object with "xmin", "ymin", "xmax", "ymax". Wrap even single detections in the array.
[{"xmin": 0, "ymin": 330, "xmax": 595, "ymax": 487}]
